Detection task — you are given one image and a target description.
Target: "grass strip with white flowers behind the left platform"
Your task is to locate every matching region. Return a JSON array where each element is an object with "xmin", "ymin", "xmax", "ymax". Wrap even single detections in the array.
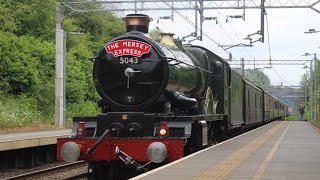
[{"xmin": 0, "ymin": 91, "xmax": 100, "ymax": 132}]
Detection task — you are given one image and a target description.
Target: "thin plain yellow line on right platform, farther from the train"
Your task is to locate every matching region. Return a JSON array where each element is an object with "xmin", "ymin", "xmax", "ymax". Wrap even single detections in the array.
[{"xmin": 252, "ymin": 122, "xmax": 291, "ymax": 180}]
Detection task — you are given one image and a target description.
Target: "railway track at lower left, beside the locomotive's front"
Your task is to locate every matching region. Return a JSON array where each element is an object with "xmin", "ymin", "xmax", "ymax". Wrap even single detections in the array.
[{"xmin": 4, "ymin": 161, "xmax": 88, "ymax": 180}]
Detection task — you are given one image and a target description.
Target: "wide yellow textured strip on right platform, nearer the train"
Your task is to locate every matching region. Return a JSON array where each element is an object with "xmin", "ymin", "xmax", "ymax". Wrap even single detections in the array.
[{"xmin": 193, "ymin": 122, "xmax": 285, "ymax": 180}]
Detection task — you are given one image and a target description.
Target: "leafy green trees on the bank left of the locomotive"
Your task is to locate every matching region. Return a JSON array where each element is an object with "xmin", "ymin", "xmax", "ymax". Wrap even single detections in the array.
[{"xmin": 0, "ymin": 0, "xmax": 125, "ymax": 119}]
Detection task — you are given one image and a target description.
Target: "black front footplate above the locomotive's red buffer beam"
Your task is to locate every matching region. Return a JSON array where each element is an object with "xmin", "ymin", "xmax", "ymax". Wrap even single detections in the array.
[{"xmin": 71, "ymin": 112, "xmax": 227, "ymax": 138}]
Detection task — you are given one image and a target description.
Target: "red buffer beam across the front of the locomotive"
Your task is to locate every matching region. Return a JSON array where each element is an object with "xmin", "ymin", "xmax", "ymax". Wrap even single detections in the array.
[{"xmin": 57, "ymin": 136, "xmax": 184, "ymax": 162}]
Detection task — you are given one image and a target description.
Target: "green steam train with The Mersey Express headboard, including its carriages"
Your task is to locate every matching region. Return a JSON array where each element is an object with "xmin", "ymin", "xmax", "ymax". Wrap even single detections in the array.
[{"xmin": 57, "ymin": 14, "xmax": 288, "ymax": 179}]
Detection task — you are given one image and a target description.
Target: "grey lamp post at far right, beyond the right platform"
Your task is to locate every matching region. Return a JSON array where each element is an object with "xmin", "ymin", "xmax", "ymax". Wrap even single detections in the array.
[{"xmin": 304, "ymin": 53, "xmax": 318, "ymax": 121}]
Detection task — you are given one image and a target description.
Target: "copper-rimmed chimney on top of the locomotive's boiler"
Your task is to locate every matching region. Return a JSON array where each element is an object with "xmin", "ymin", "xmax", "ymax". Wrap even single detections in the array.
[{"xmin": 122, "ymin": 14, "xmax": 152, "ymax": 33}]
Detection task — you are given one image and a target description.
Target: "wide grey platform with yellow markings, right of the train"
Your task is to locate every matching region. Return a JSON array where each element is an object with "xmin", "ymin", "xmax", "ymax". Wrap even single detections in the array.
[{"xmin": 132, "ymin": 121, "xmax": 320, "ymax": 180}]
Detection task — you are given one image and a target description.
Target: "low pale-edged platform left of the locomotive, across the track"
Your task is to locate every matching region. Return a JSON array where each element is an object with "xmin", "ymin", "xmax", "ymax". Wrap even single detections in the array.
[{"xmin": 0, "ymin": 129, "xmax": 71, "ymax": 151}]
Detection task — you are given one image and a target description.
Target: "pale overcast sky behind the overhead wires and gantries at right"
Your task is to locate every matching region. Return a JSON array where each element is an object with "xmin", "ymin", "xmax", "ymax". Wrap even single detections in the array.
[{"xmin": 144, "ymin": 2, "xmax": 320, "ymax": 86}]
